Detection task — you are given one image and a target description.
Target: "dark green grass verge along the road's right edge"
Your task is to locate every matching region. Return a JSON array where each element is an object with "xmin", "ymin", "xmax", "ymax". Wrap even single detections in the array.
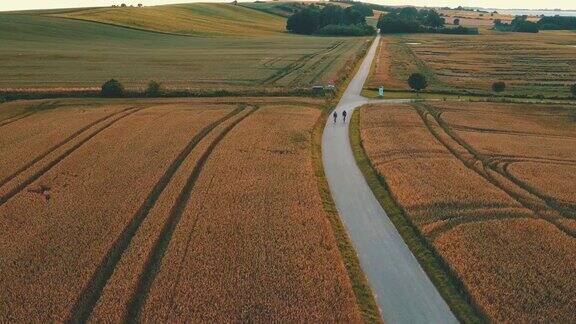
[{"xmin": 350, "ymin": 110, "xmax": 486, "ymax": 323}]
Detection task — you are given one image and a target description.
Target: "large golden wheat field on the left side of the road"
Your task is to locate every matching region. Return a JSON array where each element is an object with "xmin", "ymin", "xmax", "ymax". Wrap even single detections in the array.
[{"xmin": 0, "ymin": 98, "xmax": 361, "ymax": 322}]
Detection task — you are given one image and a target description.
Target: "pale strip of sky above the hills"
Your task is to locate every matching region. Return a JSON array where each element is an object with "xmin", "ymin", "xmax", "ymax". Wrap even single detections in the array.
[{"xmin": 0, "ymin": 0, "xmax": 576, "ymax": 11}]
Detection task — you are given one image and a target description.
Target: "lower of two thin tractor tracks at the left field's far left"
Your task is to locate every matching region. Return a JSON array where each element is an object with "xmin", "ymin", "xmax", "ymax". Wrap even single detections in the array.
[{"xmin": 0, "ymin": 107, "xmax": 145, "ymax": 206}]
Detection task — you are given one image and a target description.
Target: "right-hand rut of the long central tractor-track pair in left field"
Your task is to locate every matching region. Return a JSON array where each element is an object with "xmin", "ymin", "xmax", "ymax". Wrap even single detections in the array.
[{"xmin": 124, "ymin": 106, "xmax": 259, "ymax": 323}]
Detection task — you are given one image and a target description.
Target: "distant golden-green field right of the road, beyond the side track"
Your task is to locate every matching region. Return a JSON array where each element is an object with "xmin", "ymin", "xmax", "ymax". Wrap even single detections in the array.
[{"xmin": 369, "ymin": 31, "xmax": 576, "ymax": 97}]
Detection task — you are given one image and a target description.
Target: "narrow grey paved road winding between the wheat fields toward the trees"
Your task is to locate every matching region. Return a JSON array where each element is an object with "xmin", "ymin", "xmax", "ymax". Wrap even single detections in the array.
[{"xmin": 322, "ymin": 36, "xmax": 457, "ymax": 323}]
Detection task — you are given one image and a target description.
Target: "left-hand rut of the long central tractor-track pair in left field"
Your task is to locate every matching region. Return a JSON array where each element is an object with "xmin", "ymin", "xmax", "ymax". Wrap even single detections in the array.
[{"xmin": 70, "ymin": 107, "xmax": 244, "ymax": 323}]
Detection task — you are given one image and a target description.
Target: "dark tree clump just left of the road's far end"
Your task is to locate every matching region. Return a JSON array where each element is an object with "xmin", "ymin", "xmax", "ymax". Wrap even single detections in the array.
[{"xmin": 286, "ymin": 3, "xmax": 376, "ymax": 36}]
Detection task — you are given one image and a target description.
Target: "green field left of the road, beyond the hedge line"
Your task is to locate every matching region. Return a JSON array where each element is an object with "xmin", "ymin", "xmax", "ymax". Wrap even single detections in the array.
[{"xmin": 0, "ymin": 4, "xmax": 367, "ymax": 91}]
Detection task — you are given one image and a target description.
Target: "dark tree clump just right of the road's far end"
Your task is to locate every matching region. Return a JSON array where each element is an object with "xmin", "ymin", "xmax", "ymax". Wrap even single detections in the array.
[{"xmin": 377, "ymin": 7, "xmax": 478, "ymax": 34}]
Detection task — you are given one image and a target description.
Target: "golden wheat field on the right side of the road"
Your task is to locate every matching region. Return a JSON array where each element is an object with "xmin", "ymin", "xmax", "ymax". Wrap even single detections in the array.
[{"xmin": 360, "ymin": 102, "xmax": 576, "ymax": 322}]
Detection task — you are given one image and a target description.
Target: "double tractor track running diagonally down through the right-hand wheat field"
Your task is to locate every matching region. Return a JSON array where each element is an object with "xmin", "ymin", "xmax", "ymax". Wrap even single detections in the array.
[{"xmin": 413, "ymin": 104, "xmax": 576, "ymax": 237}]
